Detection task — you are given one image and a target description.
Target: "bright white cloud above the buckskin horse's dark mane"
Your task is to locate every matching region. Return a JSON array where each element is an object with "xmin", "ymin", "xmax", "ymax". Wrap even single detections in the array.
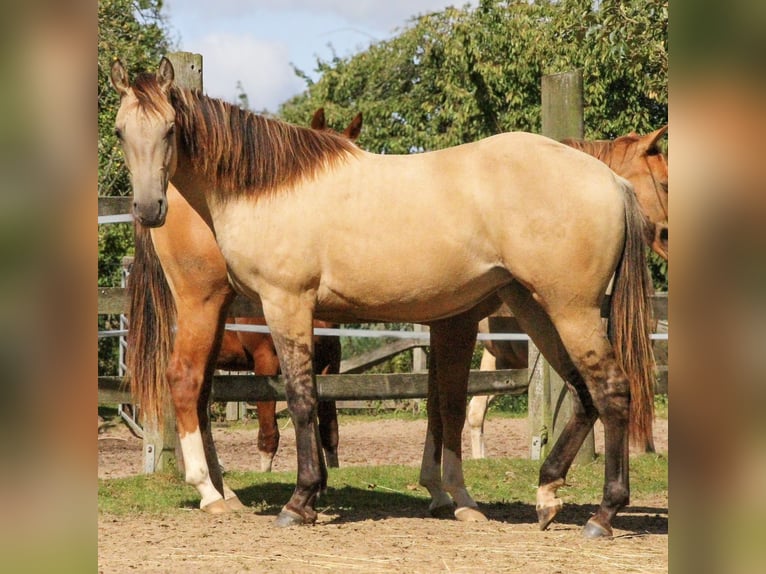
[{"xmin": 196, "ymin": 34, "xmax": 305, "ymax": 111}]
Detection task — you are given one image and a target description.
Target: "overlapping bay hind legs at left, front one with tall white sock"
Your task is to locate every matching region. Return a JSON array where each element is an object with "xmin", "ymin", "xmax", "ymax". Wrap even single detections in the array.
[{"xmin": 167, "ymin": 297, "xmax": 241, "ymax": 514}]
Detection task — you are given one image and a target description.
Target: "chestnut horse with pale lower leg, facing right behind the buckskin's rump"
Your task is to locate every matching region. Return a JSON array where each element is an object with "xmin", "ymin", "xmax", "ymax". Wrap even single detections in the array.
[{"xmin": 467, "ymin": 126, "xmax": 668, "ymax": 458}]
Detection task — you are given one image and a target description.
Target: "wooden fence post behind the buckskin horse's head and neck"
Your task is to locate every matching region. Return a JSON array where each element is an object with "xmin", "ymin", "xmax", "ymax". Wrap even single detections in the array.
[{"xmin": 144, "ymin": 52, "xmax": 202, "ymax": 474}]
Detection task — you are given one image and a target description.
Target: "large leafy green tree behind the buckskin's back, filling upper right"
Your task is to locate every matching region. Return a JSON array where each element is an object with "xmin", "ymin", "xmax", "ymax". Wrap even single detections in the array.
[{"xmin": 280, "ymin": 0, "xmax": 668, "ymax": 287}]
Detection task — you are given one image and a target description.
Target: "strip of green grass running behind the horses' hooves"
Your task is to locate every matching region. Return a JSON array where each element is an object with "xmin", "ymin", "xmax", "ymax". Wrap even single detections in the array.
[{"xmin": 98, "ymin": 454, "xmax": 668, "ymax": 518}]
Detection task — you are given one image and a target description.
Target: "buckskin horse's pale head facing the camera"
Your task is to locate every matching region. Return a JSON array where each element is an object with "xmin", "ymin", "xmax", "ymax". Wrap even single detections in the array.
[{"xmin": 111, "ymin": 58, "xmax": 177, "ymax": 227}]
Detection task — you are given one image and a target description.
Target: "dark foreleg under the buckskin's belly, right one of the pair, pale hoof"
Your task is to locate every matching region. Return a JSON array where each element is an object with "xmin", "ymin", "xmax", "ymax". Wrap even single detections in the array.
[{"xmin": 431, "ymin": 315, "xmax": 486, "ymax": 521}]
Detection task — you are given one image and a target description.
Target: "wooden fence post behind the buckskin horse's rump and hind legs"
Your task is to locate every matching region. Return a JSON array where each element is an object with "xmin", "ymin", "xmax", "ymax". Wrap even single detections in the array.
[{"xmin": 528, "ymin": 70, "xmax": 596, "ymax": 464}]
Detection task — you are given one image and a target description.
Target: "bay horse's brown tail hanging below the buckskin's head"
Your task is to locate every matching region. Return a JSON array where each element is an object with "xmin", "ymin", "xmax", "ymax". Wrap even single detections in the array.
[{"xmin": 125, "ymin": 225, "xmax": 176, "ymax": 420}]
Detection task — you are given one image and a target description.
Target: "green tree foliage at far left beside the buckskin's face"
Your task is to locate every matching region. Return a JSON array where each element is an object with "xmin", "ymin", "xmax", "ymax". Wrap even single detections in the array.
[{"xmin": 98, "ymin": 0, "xmax": 171, "ymax": 374}]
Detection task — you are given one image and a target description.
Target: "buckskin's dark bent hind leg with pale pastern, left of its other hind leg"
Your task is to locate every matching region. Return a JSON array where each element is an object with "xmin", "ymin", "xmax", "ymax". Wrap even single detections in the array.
[{"xmin": 501, "ymin": 282, "xmax": 598, "ymax": 530}]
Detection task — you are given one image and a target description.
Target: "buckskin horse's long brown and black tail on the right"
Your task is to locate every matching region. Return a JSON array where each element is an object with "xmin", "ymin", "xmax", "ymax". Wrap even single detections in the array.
[{"xmin": 609, "ymin": 178, "xmax": 654, "ymax": 444}]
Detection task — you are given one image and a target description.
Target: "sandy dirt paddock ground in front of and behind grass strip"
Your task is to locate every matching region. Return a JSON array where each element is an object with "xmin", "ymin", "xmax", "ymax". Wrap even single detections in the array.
[{"xmin": 98, "ymin": 418, "xmax": 668, "ymax": 574}]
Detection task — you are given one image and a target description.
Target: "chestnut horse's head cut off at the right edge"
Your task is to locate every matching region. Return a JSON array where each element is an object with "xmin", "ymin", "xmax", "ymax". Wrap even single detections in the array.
[{"xmin": 610, "ymin": 126, "xmax": 668, "ymax": 260}]
